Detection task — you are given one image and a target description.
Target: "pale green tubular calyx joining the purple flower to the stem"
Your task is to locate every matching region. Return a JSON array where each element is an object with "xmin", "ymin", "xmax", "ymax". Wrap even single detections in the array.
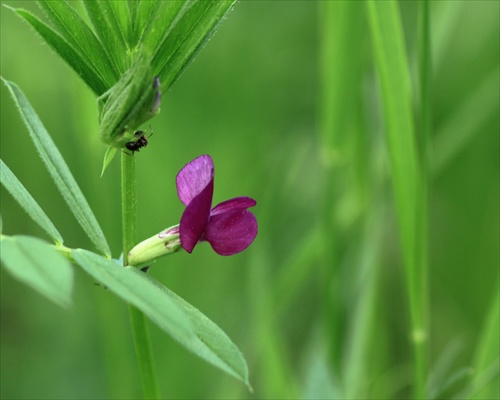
[{"xmin": 127, "ymin": 225, "xmax": 182, "ymax": 267}]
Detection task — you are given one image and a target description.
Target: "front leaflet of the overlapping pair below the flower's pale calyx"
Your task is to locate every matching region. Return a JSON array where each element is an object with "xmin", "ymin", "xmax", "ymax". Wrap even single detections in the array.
[{"xmin": 72, "ymin": 249, "xmax": 195, "ymax": 346}]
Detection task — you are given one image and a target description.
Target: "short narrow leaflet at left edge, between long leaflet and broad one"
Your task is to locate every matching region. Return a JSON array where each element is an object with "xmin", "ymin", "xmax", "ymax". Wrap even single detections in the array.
[{"xmin": 0, "ymin": 159, "xmax": 63, "ymax": 244}]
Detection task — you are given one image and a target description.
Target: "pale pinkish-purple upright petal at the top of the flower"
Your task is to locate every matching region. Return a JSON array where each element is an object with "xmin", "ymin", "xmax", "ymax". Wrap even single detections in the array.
[{"xmin": 176, "ymin": 154, "xmax": 214, "ymax": 206}]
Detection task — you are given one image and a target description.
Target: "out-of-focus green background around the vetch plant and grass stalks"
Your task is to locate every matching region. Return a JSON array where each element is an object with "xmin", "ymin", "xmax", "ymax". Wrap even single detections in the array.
[{"xmin": 0, "ymin": 1, "xmax": 500, "ymax": 399}]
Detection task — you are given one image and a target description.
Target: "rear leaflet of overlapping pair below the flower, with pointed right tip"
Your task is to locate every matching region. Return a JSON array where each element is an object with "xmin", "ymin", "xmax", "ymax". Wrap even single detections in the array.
[{"xmin": 136, "ymin": 267, "xmax": 250, "ymax": 388}]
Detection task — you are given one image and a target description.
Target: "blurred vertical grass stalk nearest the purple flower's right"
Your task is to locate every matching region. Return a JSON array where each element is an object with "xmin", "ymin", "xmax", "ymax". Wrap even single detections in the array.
[{"xmin": 318, "ymin": 1, "xmax": 358, "ymax": 371}]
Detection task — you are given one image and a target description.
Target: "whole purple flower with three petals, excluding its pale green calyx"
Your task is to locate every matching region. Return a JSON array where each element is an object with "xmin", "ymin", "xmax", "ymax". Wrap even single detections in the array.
[{"xmin": 176, "ymin": 155, "xmax": 258, "ymax": 256}]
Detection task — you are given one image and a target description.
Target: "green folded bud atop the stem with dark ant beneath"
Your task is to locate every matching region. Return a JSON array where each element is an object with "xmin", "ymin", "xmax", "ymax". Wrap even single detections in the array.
[{"xmin": 97, "ymin": 53, "xmax": 161, "ymax": 149}]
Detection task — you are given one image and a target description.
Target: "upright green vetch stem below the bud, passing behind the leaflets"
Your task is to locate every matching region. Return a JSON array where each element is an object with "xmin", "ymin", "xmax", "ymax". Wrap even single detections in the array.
[{"xmin": 121, "ymin": 152, "xmax": 159, "ymax": 399}]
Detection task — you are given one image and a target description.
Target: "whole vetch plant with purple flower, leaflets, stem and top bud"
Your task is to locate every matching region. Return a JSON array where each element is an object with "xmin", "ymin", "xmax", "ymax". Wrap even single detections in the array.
[{"xmin": 0, "ymin": 0, "xmax": 257, "ymax": 398}]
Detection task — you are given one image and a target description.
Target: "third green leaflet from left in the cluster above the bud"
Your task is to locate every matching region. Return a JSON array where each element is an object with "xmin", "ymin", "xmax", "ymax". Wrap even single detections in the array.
[{"xmin": 83, "ymin": 0, "xmax": 128, "ymax": 72}]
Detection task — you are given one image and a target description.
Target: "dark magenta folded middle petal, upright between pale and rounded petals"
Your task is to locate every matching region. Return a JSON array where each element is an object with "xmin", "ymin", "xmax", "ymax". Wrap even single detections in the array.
[{"xmin": 179, "ymin": 179, "xmax": 214, "ymax": 253}]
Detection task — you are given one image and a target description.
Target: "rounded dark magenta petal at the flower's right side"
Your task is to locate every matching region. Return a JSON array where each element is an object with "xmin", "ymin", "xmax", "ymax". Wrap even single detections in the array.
[{"xmin": 204, "ymin": 209, "xmax": 258, "ymax": 256}]
